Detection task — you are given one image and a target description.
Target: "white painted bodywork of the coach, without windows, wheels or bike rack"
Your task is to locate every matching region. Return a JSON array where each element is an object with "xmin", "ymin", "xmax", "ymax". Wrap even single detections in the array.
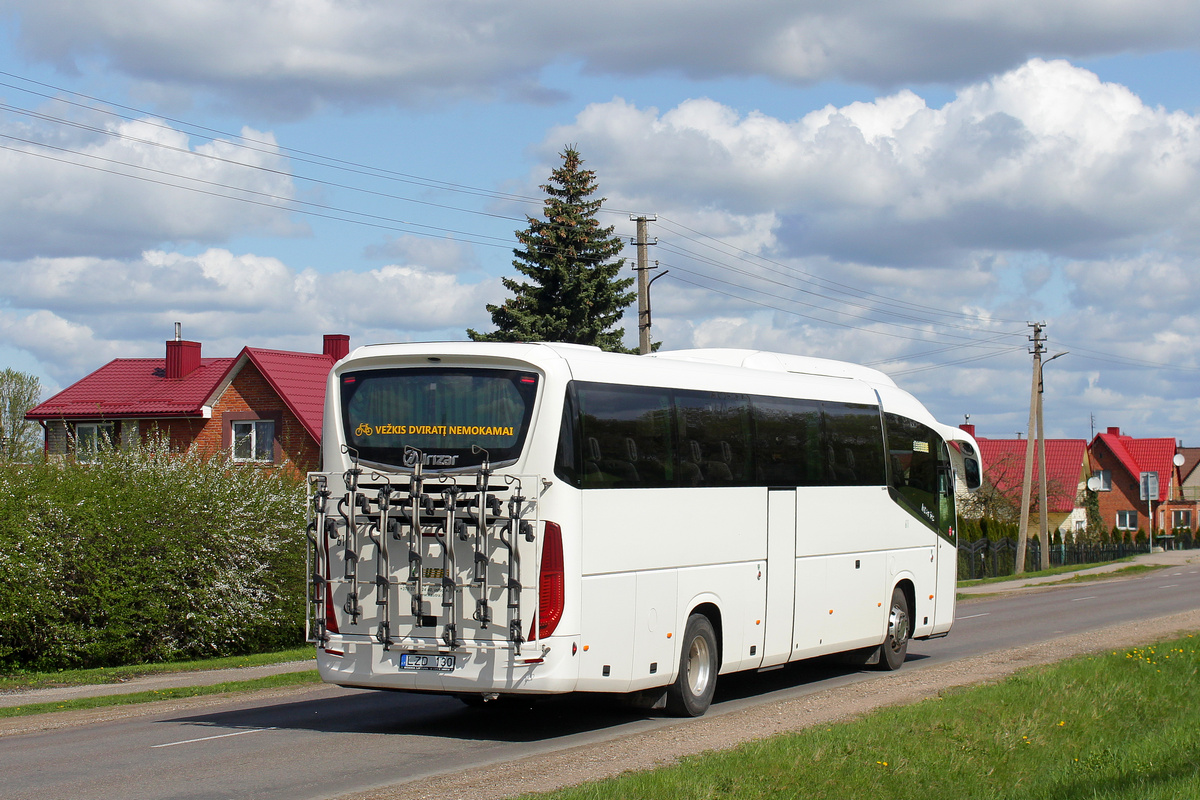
[{"xmin": 310, "ymin": 343, "xmax": 956, "ymax": 694}]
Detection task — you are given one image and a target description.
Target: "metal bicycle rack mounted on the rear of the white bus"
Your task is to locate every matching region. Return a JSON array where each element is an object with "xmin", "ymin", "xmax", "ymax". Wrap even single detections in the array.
[{"xmin": 307, "ymin": 450, "xmax": 539, "ymax": 650}]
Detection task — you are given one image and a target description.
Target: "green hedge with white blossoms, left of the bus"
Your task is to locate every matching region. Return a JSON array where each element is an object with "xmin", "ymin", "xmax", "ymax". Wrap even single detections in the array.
[{"xmin": 0, "ymin": 444, "xmax": 305, "ymax": 670}]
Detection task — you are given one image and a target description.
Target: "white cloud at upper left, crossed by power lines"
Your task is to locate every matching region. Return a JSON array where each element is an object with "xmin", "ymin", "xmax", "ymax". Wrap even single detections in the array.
[{"xmin": 0, "ymin": 108, "xmax": 301, "ymax": 260}]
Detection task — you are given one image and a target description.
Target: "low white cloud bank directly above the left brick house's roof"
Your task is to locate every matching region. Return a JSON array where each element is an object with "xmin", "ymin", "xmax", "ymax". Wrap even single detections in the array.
[{"xmin": 0, "ymin": 249, "xmax": 503, "ymax": 383}]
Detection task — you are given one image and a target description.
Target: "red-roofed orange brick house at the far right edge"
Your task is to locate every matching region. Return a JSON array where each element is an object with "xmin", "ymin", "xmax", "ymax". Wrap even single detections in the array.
[{"xmin": 1090, "ymin": 428, "xmax": 1198, "ymax": 534}]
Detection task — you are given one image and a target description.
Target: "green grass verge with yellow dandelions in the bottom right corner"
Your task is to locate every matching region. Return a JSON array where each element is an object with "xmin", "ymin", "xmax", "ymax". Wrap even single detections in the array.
[{"xmin": 527, "ymin": 636, "xmax": 1200, "ymax": 800}]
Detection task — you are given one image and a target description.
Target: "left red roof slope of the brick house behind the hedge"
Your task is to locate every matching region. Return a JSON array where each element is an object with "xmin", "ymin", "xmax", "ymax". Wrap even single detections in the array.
[{"xmin": 25, "ymin": 359, "xmax": 236, "ymax": 421}]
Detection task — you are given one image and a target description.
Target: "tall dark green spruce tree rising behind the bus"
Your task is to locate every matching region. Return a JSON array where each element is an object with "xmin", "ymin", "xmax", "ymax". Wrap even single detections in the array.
[{"xmin": 467, "ymin": 146, "xmax": 637, "ymax": 353}]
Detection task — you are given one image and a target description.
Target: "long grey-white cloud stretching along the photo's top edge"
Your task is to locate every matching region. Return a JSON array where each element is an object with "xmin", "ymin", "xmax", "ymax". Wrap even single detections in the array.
[{"xmin": 0, "ymin": 0, "xmax": 1200, "ymax": 114}]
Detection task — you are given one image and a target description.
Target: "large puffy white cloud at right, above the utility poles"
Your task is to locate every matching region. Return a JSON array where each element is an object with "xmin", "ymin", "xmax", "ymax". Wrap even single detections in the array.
[{"xmin": 549, "ymin": 60, "xmax": 1200, "ymax": 265}]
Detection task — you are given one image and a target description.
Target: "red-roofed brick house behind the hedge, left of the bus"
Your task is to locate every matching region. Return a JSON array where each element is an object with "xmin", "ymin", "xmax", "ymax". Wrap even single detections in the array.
[{"xmin": 25, "ymin": 327, "xmax": 350, "ymax": 473}]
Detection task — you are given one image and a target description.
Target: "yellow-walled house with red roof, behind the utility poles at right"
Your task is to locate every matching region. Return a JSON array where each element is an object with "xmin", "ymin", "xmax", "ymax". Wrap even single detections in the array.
[{"xmin": 964, "ymin": 426, "xmax": 1091, "ymax": 534}]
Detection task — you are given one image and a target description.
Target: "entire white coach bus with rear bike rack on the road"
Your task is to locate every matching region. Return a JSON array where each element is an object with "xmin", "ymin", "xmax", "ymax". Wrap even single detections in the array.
[{"xmin": 307, "ymin": 342, "xmax": 980, "ymax": 716}]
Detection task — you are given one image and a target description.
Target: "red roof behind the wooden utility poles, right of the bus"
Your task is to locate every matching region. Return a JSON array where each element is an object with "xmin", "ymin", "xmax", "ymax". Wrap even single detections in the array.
[{"xmin": 976, "ymin": 437, "xmax": 1087, "ymax": 513}]
